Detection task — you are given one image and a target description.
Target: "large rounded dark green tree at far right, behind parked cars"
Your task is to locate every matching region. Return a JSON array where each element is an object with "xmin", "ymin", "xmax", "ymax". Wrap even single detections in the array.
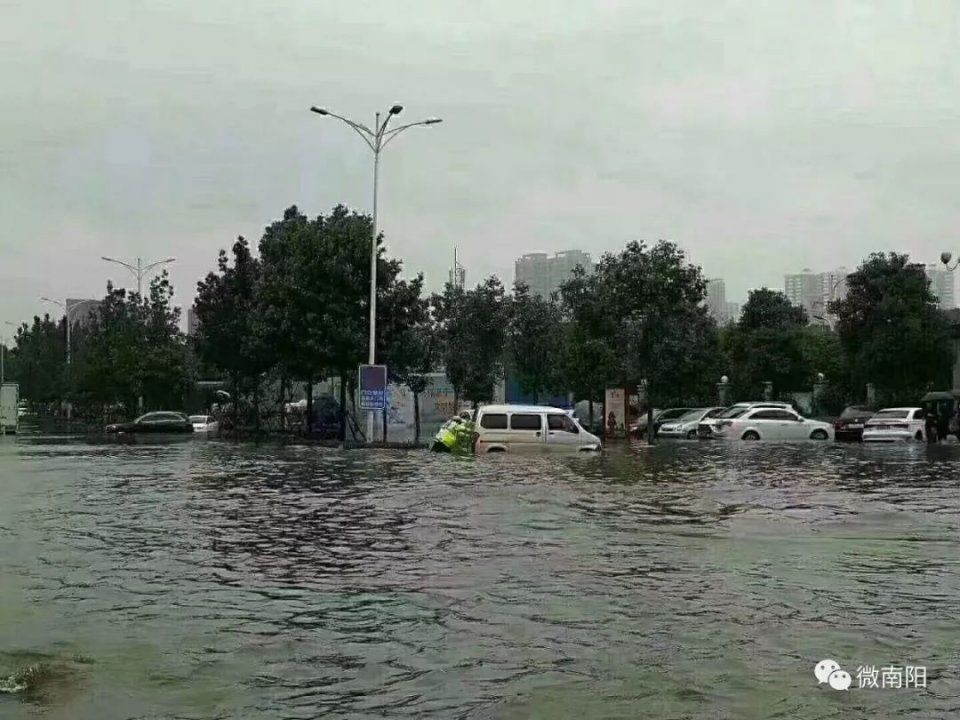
[{"xmin": 829, "ymin": 253, "xmax": 953, "ymax": 404}]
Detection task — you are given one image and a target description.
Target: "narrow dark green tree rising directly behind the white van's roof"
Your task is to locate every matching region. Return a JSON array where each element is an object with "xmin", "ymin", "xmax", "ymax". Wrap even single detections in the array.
[{"xmin": 507, "ymin": 283, "xmax": 563, "ymax": 403}]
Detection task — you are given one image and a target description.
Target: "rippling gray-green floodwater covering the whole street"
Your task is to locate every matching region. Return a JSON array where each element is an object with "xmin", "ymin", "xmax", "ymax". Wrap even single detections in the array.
[{"xmin": 0, "ymin": 436, "xmax": 960, "ymax": 720}]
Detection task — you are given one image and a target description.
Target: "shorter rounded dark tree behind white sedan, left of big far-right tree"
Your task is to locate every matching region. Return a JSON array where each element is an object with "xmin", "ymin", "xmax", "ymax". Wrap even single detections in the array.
[{"xmin": 725, "ymin": 288, "xmax": 812, "ymax": 398}]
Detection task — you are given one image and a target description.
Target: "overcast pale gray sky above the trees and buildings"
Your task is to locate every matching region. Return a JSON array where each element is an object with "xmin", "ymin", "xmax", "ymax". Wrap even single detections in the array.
[{"xmin": 0, "ymin": 0, "xmax": 960, "ymax": 335}]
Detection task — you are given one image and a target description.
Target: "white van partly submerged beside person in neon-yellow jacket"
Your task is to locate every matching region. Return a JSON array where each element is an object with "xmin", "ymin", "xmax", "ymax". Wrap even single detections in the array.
[{"xmin": 474, "ymin": 405, "xmax": 600, "ymax": 455}]
